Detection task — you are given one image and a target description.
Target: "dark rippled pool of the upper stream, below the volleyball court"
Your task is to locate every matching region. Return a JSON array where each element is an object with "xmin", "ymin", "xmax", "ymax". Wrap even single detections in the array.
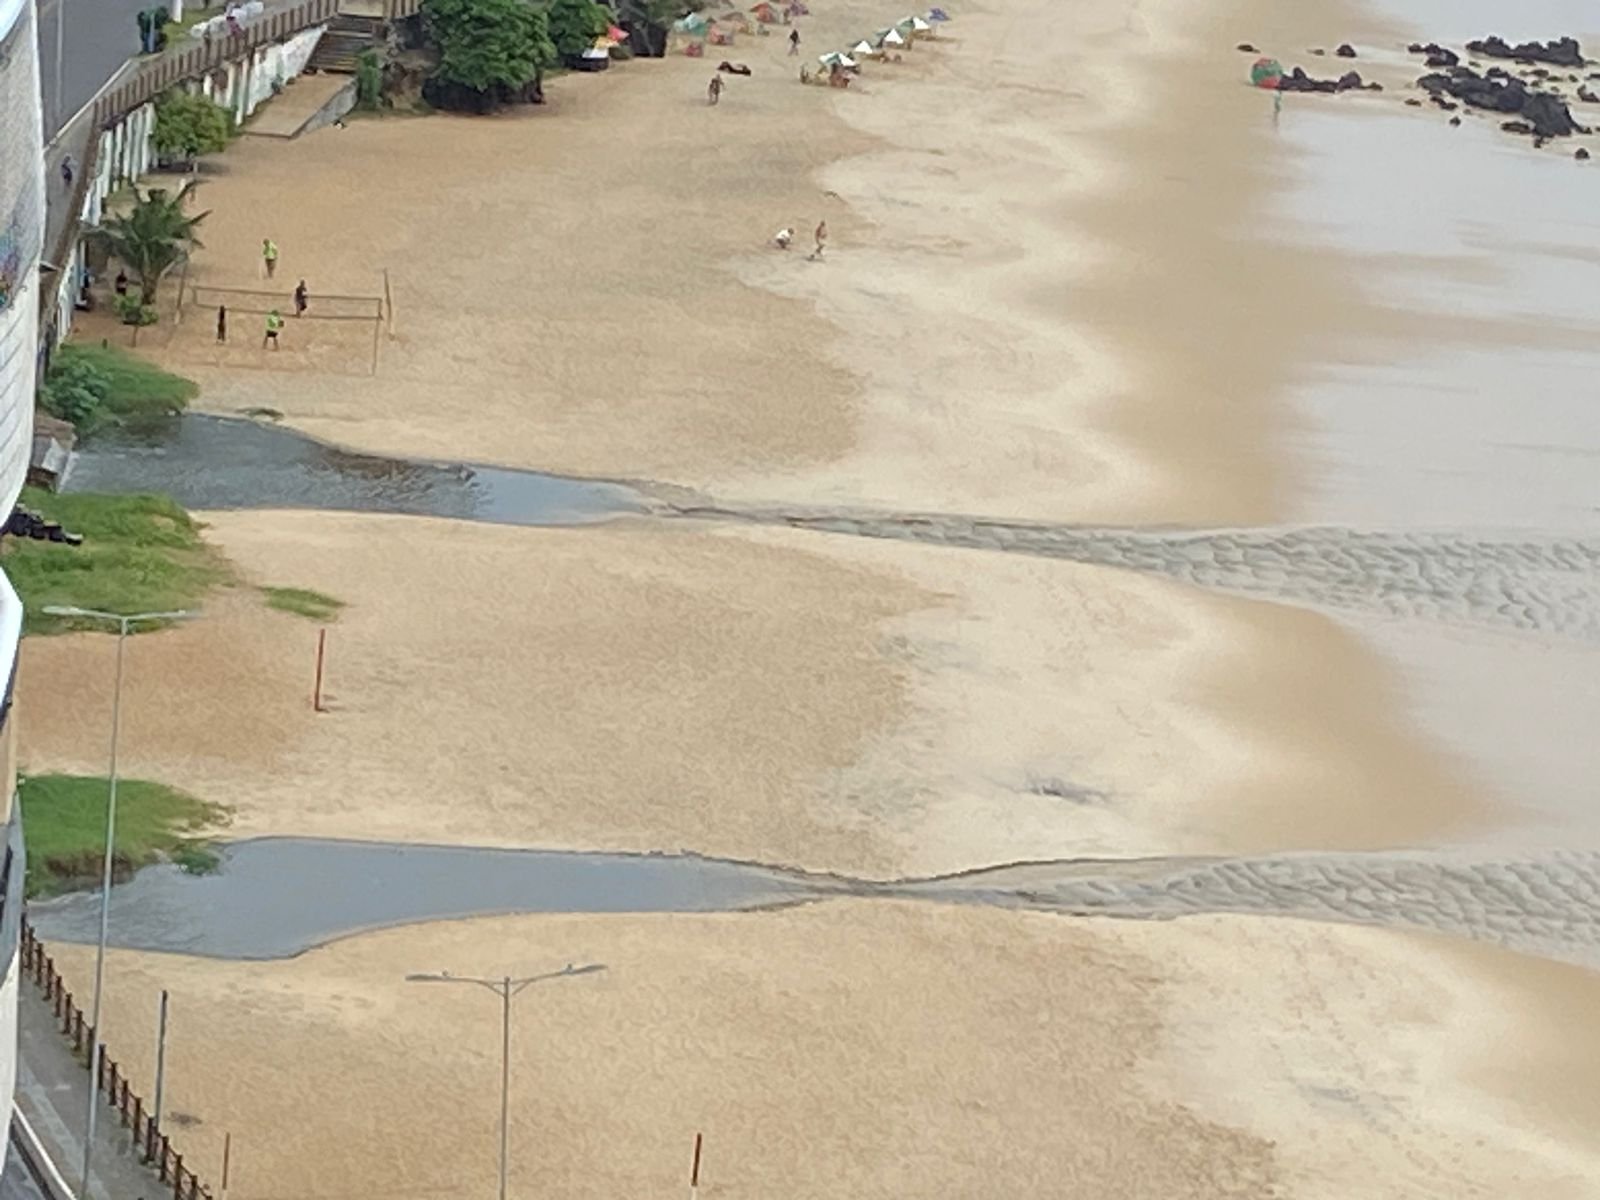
[{"xmin": 62, "ymin": 413, "xmax": 651, "ymax": 525}]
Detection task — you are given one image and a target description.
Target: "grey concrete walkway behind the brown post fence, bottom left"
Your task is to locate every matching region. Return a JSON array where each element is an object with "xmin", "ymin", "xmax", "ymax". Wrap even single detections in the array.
[{"xmin": 16, "ymin": 979, "xmax": 171, "ymax": 1200}]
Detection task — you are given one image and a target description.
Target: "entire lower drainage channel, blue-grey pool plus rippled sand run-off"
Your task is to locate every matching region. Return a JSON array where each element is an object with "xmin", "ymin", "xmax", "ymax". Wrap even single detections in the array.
[{"xmin": 29, "ymin": 837, "xmax": 1600, "ymax": 968}]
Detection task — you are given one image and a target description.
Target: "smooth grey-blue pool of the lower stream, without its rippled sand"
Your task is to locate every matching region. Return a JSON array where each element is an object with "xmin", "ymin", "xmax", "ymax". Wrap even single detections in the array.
[{"xmin": 29, "ymin": 837, "xmax": 830, "ymax": 958}]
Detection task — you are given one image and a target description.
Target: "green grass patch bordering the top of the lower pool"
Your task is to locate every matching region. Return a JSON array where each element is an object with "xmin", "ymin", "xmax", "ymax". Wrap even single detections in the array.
[{"xmin": 18, "ymin": 774, "xmax": 229, "ymax": 896}]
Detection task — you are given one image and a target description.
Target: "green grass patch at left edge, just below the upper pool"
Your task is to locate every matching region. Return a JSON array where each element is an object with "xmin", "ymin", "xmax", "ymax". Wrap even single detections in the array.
[{"xmin": 0, "ymin": 488, "xmax": 232, "ymax": 634}]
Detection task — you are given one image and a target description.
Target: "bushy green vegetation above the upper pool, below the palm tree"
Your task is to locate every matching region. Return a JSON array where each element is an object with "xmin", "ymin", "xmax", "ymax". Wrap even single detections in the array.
[{"xmin": 38, "ymin": 342, "xmax": 200, "ymax": 434}]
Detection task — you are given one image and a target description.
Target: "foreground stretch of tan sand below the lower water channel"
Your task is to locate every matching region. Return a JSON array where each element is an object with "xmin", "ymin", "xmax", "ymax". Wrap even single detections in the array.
[{"xmin": 43, "ymin": 902, "xmax": 1600, "ymax": 1200}]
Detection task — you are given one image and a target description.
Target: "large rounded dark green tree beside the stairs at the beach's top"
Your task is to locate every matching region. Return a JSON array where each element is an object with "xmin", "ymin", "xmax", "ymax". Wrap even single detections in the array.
[{"xmin": 422, "ymin": 0, "xmax": 555, "ymax": 109}]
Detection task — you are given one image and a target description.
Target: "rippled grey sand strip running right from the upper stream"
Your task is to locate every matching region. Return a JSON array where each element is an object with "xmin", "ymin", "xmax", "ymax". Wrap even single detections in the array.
[{"xmin": 678, "ymin": 507, "xmax": 1600, "ymax": 643}]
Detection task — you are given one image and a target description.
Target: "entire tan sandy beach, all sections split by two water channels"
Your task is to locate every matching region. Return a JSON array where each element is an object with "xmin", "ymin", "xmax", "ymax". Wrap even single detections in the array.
[{"xmin": 19, "ymin": 0, "xmax": 1600, "ymax": 1200}]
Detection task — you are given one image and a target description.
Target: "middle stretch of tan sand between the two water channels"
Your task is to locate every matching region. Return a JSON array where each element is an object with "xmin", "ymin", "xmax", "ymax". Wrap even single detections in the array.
[{"xmin": 19, "ymin": 512, "xmax": 1474, "ymax": 875}]
